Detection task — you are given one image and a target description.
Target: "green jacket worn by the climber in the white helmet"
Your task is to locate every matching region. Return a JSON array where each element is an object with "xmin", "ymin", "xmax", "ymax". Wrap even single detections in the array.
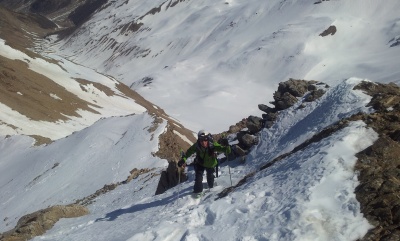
[{"xmin": 183, "ymin": 142, "xmax": 231, "ymax": 168}]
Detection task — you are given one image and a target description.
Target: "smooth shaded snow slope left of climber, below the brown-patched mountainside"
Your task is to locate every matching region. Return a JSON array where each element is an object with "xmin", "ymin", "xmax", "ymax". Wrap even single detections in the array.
[{"xmin": 0, "ymin": 113, "xmax": 167, "ymax": 232}]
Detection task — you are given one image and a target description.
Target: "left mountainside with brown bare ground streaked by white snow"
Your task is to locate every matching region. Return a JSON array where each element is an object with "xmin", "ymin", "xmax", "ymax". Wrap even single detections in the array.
[{"xmin": 0, "ymin": 4, "xmax": 193, "ymax": 149}]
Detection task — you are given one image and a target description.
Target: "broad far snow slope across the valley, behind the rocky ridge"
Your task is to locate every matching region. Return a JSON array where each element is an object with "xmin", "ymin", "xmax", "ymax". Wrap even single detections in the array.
[{"xmin": 45, "ymin": 0, "xmax": 400, "ymax": 132}]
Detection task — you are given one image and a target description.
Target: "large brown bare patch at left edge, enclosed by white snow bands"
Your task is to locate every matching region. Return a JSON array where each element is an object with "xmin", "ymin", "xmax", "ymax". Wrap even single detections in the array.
[{"xmin": 0, "ymin": 56, "xmax": 98, "ymax": 122}]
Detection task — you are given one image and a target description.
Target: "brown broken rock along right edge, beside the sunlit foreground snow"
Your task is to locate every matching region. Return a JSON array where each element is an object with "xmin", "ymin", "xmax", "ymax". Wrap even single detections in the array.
[{"xmin": 355, "ymin": 82, "xmax": 400, "ymax": 241}]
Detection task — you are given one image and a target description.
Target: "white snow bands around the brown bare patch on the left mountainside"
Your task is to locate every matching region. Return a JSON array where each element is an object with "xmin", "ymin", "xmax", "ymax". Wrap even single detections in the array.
[{"xmin": 0, "ymin": 39, "xmax": 146, "ymax": 140}]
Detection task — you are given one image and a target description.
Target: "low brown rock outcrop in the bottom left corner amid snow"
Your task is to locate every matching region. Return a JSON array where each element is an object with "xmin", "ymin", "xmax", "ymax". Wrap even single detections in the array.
[{"xmin": 0, "ymin": 204, "xmax": 89, "ymax": 241}]
